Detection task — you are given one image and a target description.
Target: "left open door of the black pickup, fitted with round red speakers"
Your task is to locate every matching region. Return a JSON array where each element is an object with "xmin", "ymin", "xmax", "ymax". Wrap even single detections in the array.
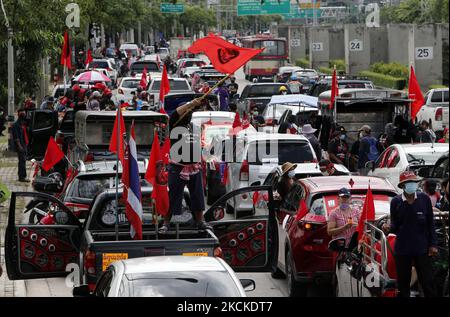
[{"xmin": 5, "ymin": 192, "xmax": 81, "ymax": 280}]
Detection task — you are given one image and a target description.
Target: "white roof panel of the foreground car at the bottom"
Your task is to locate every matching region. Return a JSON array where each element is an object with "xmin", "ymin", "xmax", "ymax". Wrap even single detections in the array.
[{"xmin": 121, "ymin": 256, "xmax": 227, "ymax": 274}]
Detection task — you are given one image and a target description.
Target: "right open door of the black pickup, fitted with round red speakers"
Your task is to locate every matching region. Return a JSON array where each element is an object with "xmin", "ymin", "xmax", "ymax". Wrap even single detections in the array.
[{"xmin": 205, "ymin": 186, "xmax": 277, "ymax": 272}]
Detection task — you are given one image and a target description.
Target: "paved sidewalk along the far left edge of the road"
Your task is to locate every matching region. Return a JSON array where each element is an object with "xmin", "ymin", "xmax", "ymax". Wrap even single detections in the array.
[{"xmin": 0, "ymin": 136, "xmax": 32, "ymax": 297}]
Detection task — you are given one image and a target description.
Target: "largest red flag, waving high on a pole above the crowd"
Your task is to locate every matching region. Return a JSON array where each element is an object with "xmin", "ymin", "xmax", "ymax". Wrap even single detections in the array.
[{"xmin": 188, "ymin": 34, "xmax": 264, "ymax": 74}]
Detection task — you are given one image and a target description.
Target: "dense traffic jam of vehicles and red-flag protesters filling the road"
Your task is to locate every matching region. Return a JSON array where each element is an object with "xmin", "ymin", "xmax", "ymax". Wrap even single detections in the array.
[{"xmin": 4, "ymin": 30, "xmax": 449, "ymax": 298}]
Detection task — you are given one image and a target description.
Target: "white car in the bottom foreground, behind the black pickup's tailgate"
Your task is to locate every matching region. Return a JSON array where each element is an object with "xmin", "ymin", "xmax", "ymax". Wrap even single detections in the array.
[{"xmin": 73, "ymin": 256, "xmax": 255, "ymax": 298}]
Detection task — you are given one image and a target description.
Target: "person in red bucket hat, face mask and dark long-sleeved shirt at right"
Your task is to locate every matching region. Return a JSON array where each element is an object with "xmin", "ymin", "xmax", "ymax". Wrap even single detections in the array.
[{"xmin": 390, "ymin": 171, "xmax": 438, "ymax": 297}]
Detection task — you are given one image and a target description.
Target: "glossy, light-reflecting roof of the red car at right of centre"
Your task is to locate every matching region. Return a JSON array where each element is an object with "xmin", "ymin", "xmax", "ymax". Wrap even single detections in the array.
[{"xmin": 301, "ymin": 176, "xmax": 397, "ymax": 193}]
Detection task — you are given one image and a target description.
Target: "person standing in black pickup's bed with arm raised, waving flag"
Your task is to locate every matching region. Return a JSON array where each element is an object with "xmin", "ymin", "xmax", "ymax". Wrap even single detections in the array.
[{"xmin": 159, "ymin": 99, "xmax": 212, "ymax": 234}]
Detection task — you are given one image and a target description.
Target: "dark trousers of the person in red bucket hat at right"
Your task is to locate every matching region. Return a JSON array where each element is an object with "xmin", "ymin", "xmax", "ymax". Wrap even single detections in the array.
[{"xmin": 395, "ymin": 254, "xmax": 436, "ymax": 297}]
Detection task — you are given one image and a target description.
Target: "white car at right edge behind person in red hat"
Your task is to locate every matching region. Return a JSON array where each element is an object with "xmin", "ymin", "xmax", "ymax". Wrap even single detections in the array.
[{"xmin": 366, "ymin": 143, "xmax": 448, "ymax": 186}]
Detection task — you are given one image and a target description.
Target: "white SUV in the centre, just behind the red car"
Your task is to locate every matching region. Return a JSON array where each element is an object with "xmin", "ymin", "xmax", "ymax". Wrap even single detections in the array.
[{"xmin": 216, "ymin": 131, "xmax": 317, "ymax": 212}]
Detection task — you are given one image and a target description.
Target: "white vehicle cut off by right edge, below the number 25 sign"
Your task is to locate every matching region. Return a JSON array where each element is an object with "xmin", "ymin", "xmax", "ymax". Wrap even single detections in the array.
[{"xmin": 417, "ymin": 88, "xmax": 449, "ymax": 131}]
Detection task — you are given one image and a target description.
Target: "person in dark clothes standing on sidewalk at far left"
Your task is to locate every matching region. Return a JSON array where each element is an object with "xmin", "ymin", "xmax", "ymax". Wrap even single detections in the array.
[{"xmin": 12, "ymin": 108, "xmax": 30, "ymax": 183}]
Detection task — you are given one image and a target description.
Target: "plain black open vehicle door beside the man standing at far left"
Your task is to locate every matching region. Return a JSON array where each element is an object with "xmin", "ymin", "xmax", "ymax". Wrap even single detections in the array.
[{"xmin": 28, "ymin": 110, "xmax": 58, "ymax": 160}]
